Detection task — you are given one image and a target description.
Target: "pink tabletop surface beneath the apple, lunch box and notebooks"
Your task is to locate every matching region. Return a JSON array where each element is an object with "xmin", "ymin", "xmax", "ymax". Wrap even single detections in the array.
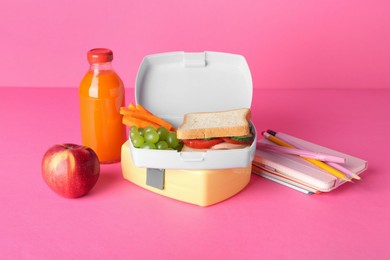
[{"xmin": 0, "ymin": 88, "xmax": 390, "ymax": 259}]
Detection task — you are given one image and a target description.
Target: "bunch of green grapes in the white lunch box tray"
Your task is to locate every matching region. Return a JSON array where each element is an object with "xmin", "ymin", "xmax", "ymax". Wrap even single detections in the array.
[{"xmin": 130, "ymin": 126, "xmax": 183, "ymax": 150}]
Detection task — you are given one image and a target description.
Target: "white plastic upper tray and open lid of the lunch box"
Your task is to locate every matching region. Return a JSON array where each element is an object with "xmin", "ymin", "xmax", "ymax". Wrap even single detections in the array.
[{"xmin": 130, "ymin": 52, "xmax": 256, "ymax": 169}]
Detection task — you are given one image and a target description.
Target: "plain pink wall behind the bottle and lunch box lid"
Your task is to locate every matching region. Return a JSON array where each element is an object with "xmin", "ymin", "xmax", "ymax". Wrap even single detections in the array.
[{"xmin": 0, "ymin": 0, "xmax": 390, "ymax": 88}]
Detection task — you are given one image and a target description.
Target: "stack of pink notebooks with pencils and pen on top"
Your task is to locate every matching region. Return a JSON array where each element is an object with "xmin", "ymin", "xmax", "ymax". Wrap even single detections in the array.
[{"xmin": 252, "ymin": 130, "xmax": 367, "ymax": 194}]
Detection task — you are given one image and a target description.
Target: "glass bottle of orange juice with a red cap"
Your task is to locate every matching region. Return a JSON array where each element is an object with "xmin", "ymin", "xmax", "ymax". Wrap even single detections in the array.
[{"xmin": 79, "ymin": 48, "xmax": 126, "ymax": 163}]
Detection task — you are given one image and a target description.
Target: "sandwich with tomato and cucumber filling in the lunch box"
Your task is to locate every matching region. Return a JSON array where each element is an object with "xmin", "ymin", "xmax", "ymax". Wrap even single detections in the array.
[{"xmin": 177, "ymin": 108, "xmax": 254, "ymax": 151}]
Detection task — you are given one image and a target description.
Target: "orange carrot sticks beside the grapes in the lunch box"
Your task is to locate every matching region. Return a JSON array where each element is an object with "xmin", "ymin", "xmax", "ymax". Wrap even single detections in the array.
[{"xmin": 120, "ymin": 104, "xmax": 174, "ymax": 131}]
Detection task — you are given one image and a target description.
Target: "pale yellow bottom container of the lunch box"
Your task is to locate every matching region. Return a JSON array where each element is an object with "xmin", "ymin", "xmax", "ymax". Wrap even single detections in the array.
[{"xmin": 121, "ymin": 141, "xmax": 252, "ymax": 206}]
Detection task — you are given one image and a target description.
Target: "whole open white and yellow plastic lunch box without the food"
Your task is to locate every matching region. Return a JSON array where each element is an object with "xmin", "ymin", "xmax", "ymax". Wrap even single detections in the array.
[{"xmin": 121, "ymin": 52, "xmax": 256, "ymax": 206}]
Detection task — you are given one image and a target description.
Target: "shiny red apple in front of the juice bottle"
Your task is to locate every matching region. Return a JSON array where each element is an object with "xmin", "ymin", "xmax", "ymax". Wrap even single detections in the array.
[{"xmin": 42, "ymin": 144, "xmax": 100, "ymax": 198}]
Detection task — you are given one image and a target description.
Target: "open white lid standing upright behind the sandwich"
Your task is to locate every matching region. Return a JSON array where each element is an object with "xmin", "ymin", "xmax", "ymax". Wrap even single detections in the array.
[{"xmin": 135, "ymin": 52, "xmax": 252, "ymax": 127}]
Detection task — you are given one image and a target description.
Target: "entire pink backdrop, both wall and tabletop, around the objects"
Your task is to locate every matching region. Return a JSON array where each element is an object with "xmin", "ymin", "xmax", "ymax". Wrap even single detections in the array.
[{"xmin": 0, "ymin": 0, "xmax": 390, "ymax": 260}]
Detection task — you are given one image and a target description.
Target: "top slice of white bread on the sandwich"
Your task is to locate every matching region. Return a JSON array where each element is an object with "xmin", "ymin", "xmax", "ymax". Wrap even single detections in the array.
[{"xmin": 177, "ymin": 108, "xmax": 251, "ymax": 139}]
